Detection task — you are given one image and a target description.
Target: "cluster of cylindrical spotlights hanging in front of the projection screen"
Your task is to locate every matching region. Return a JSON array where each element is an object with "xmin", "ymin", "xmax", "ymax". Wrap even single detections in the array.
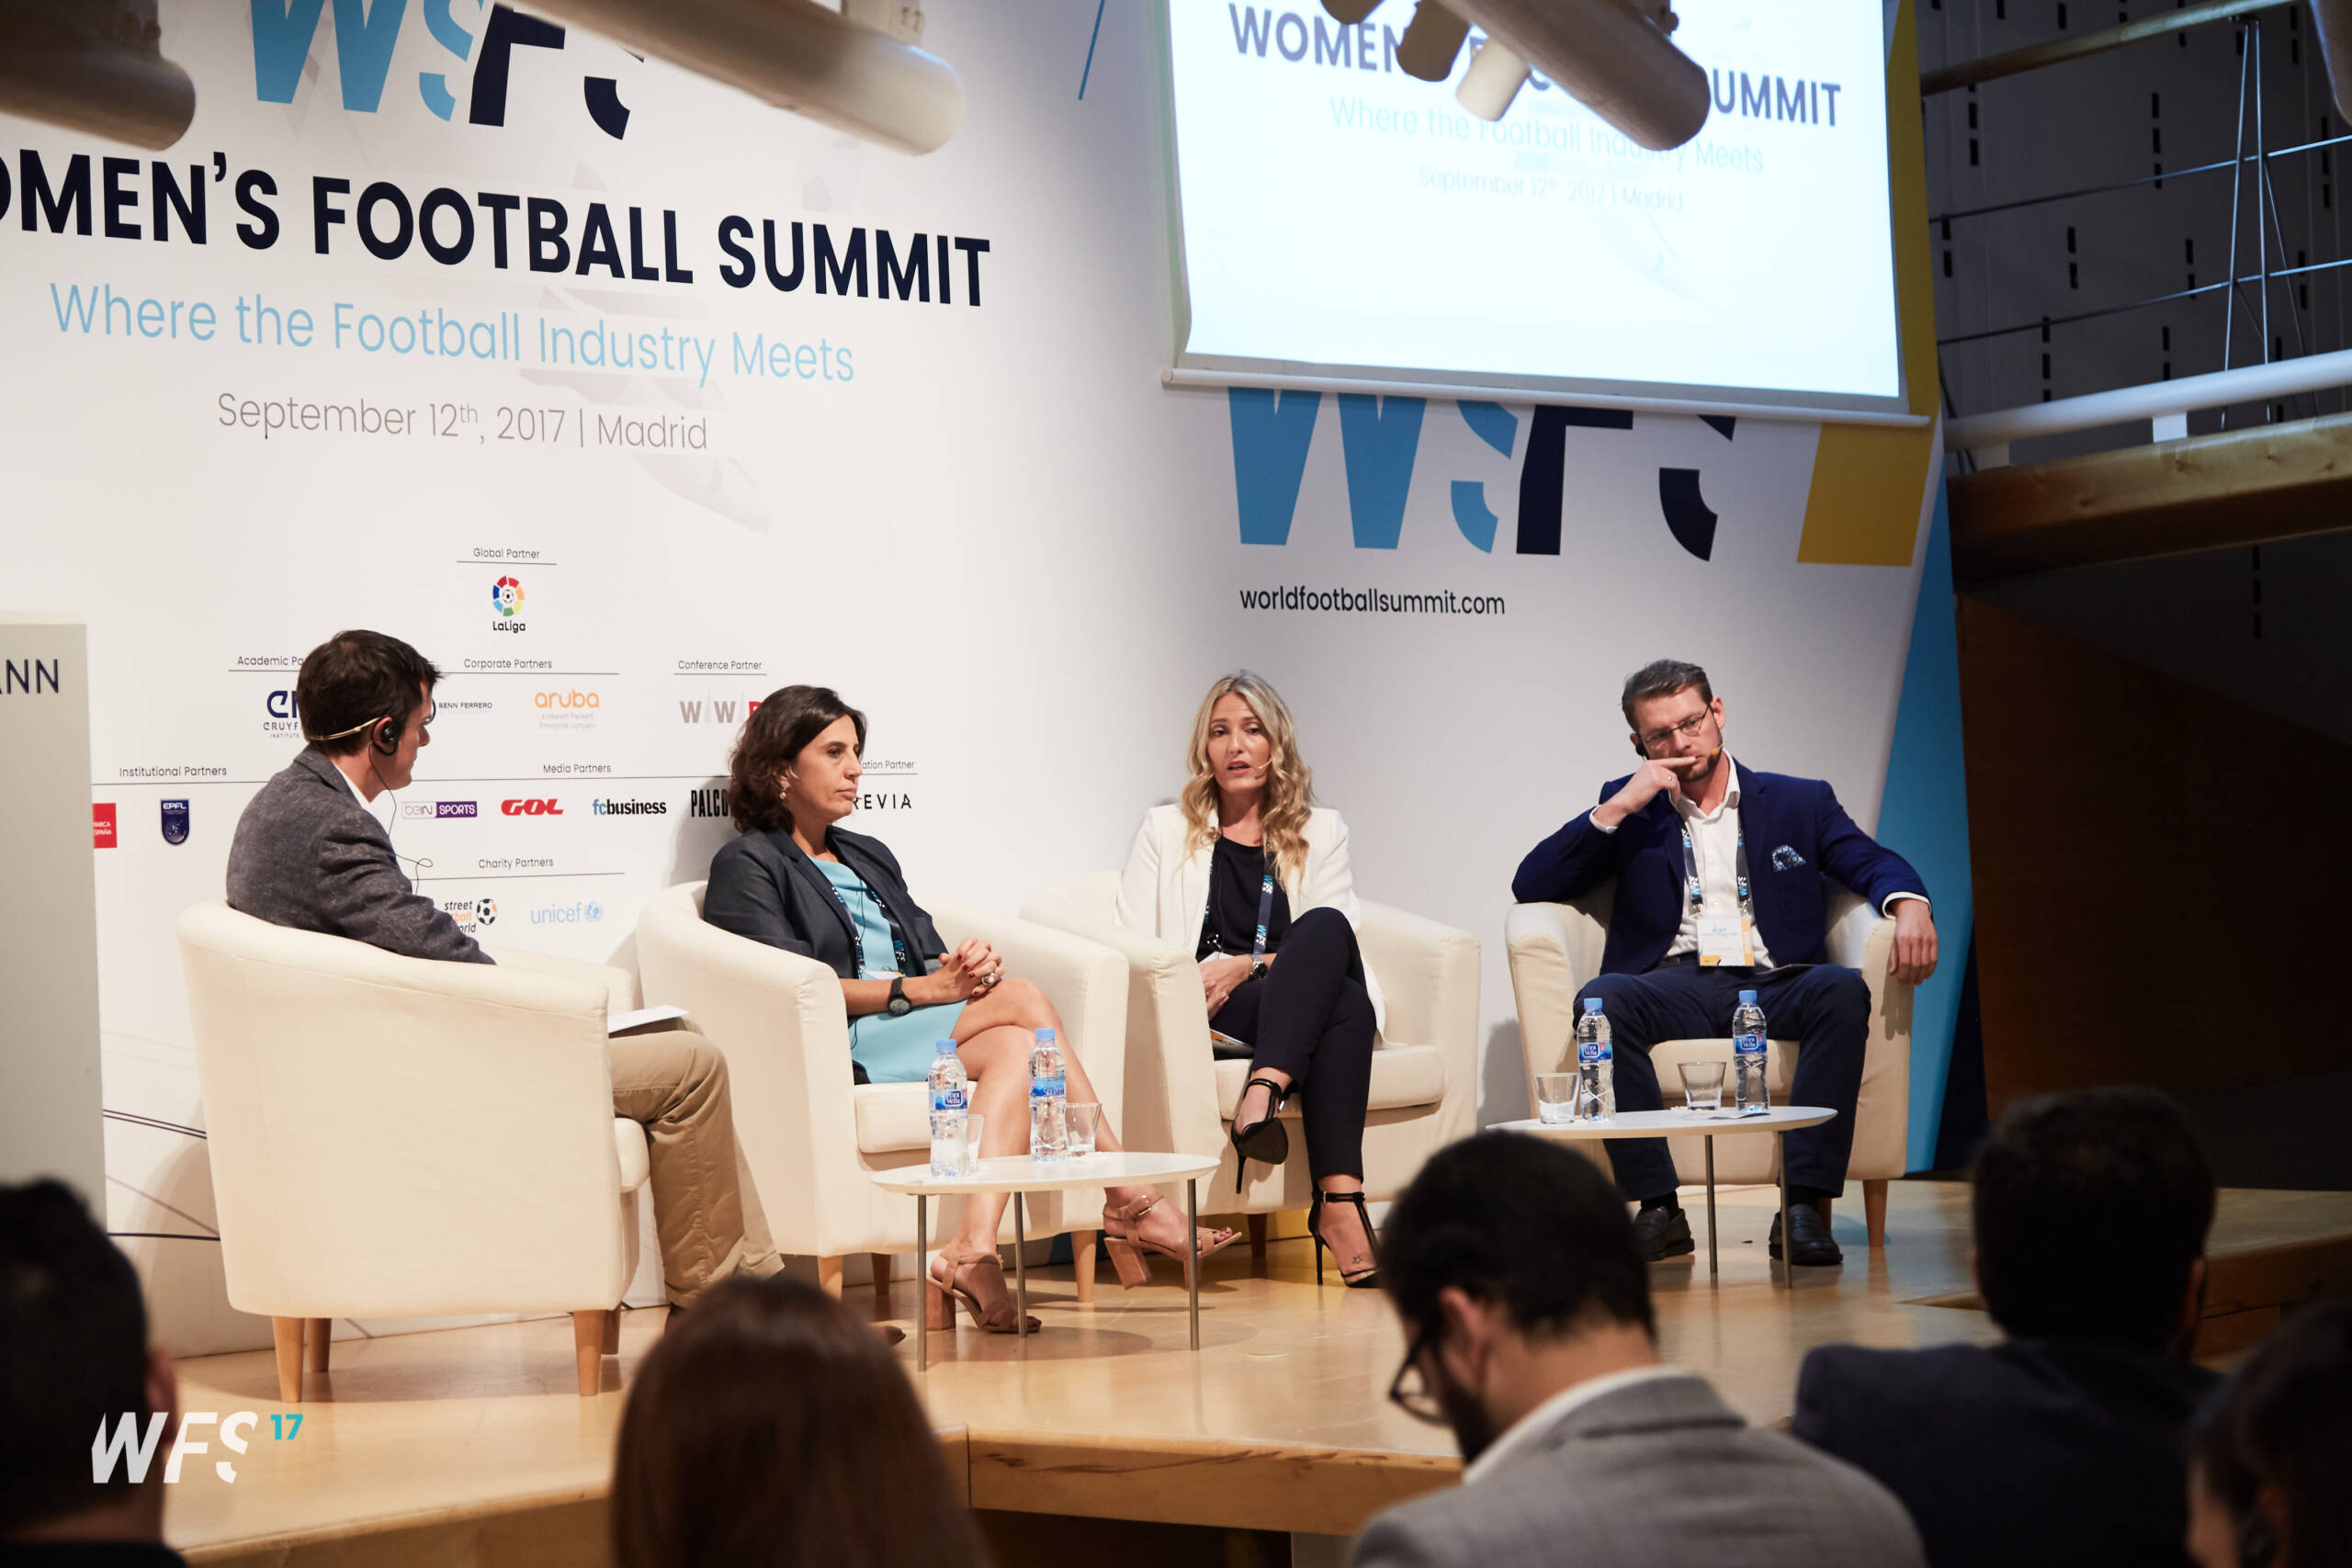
[{"xmin": 1324, "ymin": 0, "xmax": 1710, "ymax": 152}]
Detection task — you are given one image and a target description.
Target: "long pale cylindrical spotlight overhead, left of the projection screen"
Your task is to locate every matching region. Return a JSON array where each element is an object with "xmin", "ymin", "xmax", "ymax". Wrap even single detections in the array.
[{"xmin": 532, "ymin": 0, "xmax": 965, "ymax": 152}]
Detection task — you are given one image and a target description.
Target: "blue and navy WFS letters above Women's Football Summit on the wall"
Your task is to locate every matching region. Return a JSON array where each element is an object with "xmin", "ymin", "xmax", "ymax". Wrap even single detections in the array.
[{"xmin": 252, "ymin": 0, "xmax": 628, "ymax": 141}]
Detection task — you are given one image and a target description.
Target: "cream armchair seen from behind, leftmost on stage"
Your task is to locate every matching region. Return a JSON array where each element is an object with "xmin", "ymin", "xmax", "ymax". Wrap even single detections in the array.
[{"xmin": 179, "ymin": 903, "xmax": 647, "ymax": 1404}]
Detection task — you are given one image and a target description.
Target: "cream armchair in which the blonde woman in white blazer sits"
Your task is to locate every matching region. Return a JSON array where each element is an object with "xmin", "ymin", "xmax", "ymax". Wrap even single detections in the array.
[{"xmin": 1021, "ymin": 872, "xmax": 1477, "ymax": 1251}]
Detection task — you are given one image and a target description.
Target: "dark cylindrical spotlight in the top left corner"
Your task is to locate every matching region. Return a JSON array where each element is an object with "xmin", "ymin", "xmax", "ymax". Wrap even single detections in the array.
[{"xmin": 0, "ymin": 0, "xmax": 195, "ymax": 151}]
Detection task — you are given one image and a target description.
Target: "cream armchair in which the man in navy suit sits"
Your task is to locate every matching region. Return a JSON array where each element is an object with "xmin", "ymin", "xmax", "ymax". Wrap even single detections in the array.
[{"xmin": 1503, "ymin": 884, "xmax": 1912, "ymax": 1246}]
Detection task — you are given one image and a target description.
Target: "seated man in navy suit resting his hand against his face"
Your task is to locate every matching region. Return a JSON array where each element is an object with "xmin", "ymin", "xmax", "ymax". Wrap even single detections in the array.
[{"xmin": 1510, "ymin": 659, "xmax": 1936, "ymax": 1265}]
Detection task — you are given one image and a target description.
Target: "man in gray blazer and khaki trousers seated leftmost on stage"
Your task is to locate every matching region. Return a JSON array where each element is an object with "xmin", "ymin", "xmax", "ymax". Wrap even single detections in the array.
[{"xmin": 228, "ymin": 632, "xmax": 783, "ymax": 1307}]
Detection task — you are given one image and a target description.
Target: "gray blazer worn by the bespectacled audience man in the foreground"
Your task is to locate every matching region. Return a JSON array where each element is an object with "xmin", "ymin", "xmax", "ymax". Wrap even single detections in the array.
[{"xmin": 1352, "ymin": 1375, "xmax": 1924, "ymax": 1568}]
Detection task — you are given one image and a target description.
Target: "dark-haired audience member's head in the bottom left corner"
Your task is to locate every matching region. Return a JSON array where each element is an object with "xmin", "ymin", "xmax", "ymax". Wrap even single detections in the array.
[{"xmin": 0, "ymin": 1180, "xmax": 179, "ymax": 1542}]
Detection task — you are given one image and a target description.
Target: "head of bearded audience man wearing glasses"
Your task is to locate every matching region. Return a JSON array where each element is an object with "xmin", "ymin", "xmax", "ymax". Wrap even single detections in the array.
[{"xmin": 1381, "ymin": 1134, "xmax": 1656, "ymax": 1460}]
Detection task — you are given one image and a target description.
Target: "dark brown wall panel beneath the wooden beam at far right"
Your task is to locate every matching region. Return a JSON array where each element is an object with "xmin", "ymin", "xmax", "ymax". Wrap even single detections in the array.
[{"xmin": 1959, "ymin": 597, "xmax": 2352, "ymax": 1114}]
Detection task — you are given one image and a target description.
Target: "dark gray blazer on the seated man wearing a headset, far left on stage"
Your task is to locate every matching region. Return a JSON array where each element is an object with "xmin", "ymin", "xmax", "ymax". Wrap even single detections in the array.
[{"xmin": 228, "ymin": 745, "xmax": 492, "ymax": 964}]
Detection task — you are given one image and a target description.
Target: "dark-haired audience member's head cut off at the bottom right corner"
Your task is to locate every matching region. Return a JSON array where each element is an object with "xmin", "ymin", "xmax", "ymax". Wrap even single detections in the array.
[{"xmin": 2188, "ymin": 1303, "xmax": 2352, "ymax": 1568}]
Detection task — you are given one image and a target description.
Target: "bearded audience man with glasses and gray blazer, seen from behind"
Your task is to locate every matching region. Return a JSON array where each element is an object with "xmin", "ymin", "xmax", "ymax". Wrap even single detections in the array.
[{"xmin": 1352, "ymin": 1134, "xmax": 1924, "ymax": 1568}]
